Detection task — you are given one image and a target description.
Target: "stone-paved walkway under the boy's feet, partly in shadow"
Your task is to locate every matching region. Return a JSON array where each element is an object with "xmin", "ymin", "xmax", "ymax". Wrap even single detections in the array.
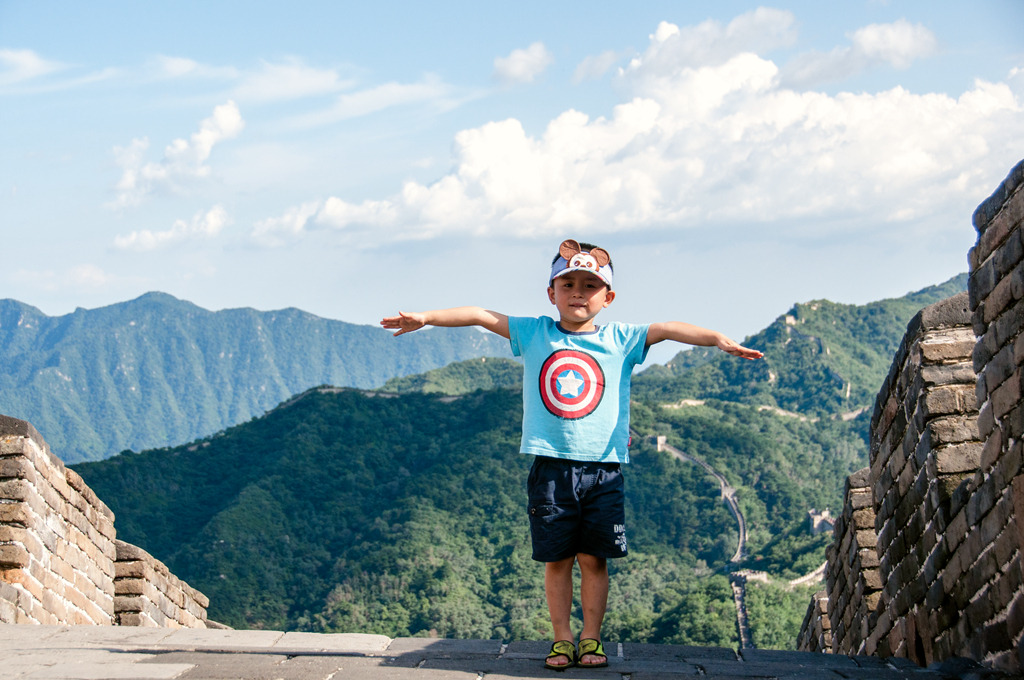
[{"xmin": 0, "ymin": 625, "xmax": 1006, "ymax": 680}]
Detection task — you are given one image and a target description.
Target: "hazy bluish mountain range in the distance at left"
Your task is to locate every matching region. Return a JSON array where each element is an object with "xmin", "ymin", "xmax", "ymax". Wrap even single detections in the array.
[{"xmin": 0, "ymin": 293, "xmax": 511, "ymax": 462}]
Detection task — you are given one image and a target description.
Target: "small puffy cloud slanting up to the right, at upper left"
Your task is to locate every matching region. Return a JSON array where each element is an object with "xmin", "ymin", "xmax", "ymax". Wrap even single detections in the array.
[{"xmin": 109, "ymin": 101, "xmax": 246, "ymax": 208}]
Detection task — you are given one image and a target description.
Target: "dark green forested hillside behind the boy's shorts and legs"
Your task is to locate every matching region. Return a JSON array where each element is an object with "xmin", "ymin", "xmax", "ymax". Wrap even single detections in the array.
[{"xmin": 76, "ymin": 389, "xmax": 863, "ymax": 644}]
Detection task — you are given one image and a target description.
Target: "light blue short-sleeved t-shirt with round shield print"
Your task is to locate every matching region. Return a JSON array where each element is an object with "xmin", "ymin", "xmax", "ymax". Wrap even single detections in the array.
[{"xmin": 509, "ymin": 316, "xmax": 647, "ymax": 463}]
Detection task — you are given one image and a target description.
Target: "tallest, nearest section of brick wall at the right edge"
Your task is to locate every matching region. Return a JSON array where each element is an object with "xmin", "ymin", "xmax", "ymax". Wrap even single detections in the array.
[{"xmin": 962, "ymin": 157, "xmax": 1024, "ymax": 669}]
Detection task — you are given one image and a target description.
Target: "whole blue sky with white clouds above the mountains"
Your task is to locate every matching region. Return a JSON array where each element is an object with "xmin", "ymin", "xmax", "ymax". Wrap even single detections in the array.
[{"xmin": 0, "ymin": 0, "xmax": 1024, "ymax": 360}]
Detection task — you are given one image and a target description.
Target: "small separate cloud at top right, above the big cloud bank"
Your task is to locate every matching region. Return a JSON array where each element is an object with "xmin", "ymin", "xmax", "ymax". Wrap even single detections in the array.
[{"xmin": 780, "ymin": 18, "xmax": 939, "ymax": 88}]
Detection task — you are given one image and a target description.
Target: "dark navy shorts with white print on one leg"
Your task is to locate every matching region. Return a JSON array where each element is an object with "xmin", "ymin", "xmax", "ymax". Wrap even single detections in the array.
[{"xmin": 527, "ymin": 456, "xmax": 627, "ymax": 562}]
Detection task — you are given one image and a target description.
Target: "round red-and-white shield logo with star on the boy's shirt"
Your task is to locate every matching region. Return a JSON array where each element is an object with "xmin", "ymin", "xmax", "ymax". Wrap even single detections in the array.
[{"xmin": 541, "ymin": 349, "xmax": 604, "ymax": 420}]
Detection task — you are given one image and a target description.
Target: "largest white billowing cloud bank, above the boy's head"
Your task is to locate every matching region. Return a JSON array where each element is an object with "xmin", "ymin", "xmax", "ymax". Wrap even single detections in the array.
[{"xmin": 251, "ymin": 10, "xmax": 1024, "ymax": 244}]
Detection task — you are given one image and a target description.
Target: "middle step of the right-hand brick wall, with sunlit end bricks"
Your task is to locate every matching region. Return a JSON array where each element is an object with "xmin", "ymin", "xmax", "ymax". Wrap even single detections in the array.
[{"xmin": 863, "ymin": 293, "xmax": 983, "ymax": 665}]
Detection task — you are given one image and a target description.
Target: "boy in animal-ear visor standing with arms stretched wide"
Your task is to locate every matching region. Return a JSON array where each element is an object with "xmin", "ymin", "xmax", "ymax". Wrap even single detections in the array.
[{"xmin": 381, "ymin": 240, "xmax": 762, "ymax": 671}]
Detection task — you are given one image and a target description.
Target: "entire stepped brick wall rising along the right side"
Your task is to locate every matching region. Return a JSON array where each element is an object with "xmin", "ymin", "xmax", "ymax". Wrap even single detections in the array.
[{"xmin": 799, "ymin": 157, "xmax": 1024, "ymax": 671}]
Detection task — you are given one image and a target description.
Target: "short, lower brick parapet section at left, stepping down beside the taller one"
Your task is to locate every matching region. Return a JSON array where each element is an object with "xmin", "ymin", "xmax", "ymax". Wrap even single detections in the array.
[{"xmin": 114, "ymin": 541, "xmax": 210, "ymax": 628}]
